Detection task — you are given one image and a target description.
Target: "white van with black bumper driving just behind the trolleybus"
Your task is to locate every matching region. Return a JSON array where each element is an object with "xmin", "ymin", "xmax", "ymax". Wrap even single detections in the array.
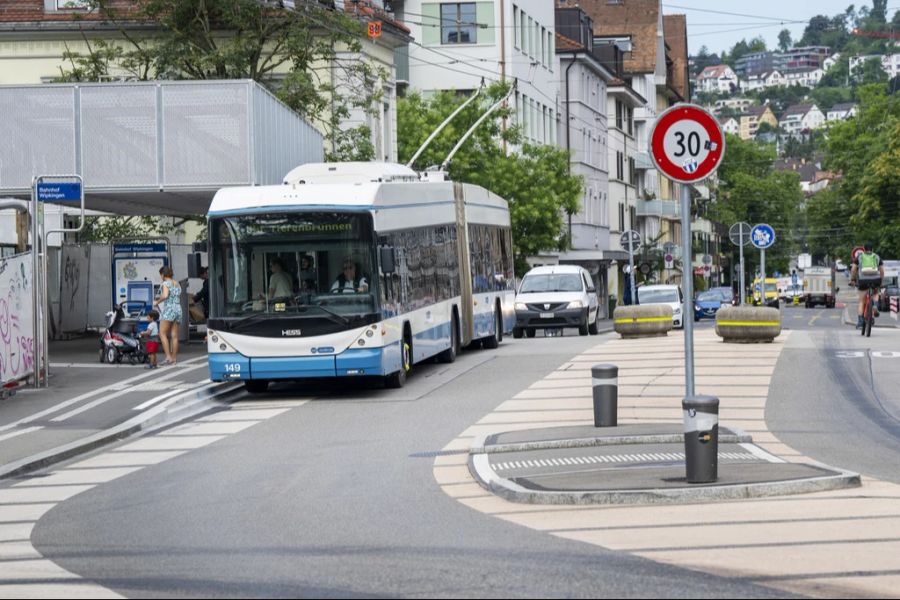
[{"xmin": 513, "ymin": 265, "xmax": 600, "ymax": 338}]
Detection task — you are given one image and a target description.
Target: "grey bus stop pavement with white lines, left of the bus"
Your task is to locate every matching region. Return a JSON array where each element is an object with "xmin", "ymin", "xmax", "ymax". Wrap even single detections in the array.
[{"xmin": 0, "ymin": 336, "xmax": 237, "ymax": 478}]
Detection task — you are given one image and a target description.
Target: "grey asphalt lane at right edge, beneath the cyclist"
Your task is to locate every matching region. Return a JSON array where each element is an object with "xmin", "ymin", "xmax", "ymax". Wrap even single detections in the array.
[{"xmin": 766, "ymin": 298, "xmax": 900, "ymax": 483}]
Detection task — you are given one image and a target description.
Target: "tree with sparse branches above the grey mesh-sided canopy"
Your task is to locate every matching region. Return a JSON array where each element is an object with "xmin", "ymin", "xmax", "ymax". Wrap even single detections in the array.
[{"xmin": 60, "ymin": 0, "xmax": 385, "ymax": 160}]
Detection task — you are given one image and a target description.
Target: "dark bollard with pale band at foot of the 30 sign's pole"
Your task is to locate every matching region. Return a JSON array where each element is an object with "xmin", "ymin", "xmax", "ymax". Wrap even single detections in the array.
[{"xmin": 681, "ymin": 396, "xmax": 719, "ymax": 483}]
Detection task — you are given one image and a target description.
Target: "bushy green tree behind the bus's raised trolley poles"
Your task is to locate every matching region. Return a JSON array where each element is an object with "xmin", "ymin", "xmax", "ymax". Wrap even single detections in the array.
[{"xmin": 397, "ymin": 84, "xmax": 583, "ymax": 272}]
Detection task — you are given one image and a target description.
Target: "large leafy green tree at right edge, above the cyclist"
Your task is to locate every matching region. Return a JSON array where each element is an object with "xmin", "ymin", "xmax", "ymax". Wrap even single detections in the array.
[{"xmin": 806, "ymin": 84, "xmax": 900, "ymax": 259}]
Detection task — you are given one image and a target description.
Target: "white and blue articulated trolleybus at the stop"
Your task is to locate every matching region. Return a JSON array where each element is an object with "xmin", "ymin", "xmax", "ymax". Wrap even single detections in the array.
[{"xmin": 207, "ymin": 163, "xmax": 515, "ymax": 392}]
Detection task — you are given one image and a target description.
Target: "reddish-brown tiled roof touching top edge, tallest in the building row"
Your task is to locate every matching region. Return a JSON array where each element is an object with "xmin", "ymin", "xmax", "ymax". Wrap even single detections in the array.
[{"xmin": 581, "ymin": 0, "xmax": 660, "ymax": 73}]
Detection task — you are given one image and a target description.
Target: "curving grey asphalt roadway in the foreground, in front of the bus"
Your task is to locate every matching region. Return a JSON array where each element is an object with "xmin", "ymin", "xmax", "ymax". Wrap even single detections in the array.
[{"xmin": 24, "ymin": 336, "xmax": 784, "ymax": 598}]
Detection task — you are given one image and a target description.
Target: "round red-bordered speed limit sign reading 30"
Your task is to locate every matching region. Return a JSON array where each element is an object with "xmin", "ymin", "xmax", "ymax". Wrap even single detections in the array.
[{"xmin": 650, "ymin": 104, "xmax": 725, "ymax": 183}]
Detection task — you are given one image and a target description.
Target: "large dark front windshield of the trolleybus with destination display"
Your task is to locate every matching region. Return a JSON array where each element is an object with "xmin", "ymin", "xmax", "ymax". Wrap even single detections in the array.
[{"xmin": 210, "ymin": 212, "xmax": 379, "ymax": 336}]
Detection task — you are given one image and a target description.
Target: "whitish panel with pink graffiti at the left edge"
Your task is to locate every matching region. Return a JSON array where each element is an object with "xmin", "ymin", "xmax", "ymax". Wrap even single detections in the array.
[{"xmin": 0, "ymin": 254, "xmax": 34, "ymax": 383}]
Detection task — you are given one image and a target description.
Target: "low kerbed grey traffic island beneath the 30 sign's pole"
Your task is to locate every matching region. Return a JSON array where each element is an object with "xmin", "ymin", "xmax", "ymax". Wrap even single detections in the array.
[{"xmin": 468, "ymin": 424, "xmax": 861, "ymax": 504}]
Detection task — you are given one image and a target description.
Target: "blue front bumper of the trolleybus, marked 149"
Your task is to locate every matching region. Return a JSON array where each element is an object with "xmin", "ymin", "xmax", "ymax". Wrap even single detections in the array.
[{"xmin": 209, "ymin": 345, "xmax": 400, "ymax": 381}]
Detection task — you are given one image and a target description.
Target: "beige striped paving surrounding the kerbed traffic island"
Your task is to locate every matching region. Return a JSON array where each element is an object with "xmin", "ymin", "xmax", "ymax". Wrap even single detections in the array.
[{"xmin": 433, "ymin": 330, "xmax": 900, "ymax": 597}]
